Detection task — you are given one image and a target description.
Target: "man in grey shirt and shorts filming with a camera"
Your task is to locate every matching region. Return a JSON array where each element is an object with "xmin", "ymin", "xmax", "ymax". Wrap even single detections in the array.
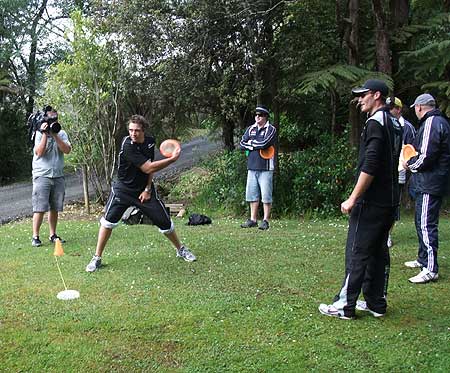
[{"xmin": 31, "ymin": 106, "xmax": 72, "ymax": 247}]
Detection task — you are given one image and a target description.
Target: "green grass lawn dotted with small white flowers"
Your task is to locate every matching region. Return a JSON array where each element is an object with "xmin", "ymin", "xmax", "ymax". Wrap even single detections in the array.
[{"xmin": 0, "ymin": 211, "xmax": 450, "ymax": 372}]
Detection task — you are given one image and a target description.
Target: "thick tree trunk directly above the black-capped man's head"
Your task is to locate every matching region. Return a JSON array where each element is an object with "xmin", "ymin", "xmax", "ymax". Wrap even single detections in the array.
[{"xmin": 372, "ymin": 0, "xmax": 392, "ymax": 75}]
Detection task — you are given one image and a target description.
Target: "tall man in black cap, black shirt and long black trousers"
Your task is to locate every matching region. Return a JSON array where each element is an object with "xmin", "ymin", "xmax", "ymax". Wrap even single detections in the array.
[{"xmin": 319, "ymin": 79, "xmax": 402, "ymax": 319}]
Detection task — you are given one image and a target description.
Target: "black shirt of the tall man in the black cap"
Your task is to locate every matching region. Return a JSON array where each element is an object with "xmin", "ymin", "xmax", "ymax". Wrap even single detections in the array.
[{"xmin": 358, "ymin": 109, "xmax": 402, "ymax": 207}]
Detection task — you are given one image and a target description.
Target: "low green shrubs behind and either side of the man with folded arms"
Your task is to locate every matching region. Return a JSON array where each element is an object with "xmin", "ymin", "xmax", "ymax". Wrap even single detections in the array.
[{"xmin": 168, "ymin": 139, "xmax": 355, "ymax": 216}]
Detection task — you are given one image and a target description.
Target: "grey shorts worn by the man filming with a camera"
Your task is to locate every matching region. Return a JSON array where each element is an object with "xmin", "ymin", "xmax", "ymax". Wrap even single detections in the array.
[{"xmin": 31, "ymin": 176, "xmax": 66, "ymax": 212}]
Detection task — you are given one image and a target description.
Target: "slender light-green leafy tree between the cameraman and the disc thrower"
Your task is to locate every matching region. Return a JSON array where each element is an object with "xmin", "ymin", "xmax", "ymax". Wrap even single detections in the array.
[{"xmin": 44, "ymin": 12, "xmax": 126, "ymax": 198}]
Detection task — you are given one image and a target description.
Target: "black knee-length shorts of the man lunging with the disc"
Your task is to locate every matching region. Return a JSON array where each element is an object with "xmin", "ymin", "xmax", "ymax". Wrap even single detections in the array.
[{"xmin": 101, "ymin": 184, "xmax": 173, "ymax": 232}]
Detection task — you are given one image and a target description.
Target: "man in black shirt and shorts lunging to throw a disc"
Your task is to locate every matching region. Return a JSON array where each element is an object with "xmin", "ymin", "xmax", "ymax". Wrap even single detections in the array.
[{"xmin": 86, "ymin": 115, "xmax": 196, "ymax": 272}]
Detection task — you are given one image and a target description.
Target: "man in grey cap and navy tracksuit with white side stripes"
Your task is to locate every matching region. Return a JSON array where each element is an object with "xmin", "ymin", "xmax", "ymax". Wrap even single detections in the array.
[{"xmin": 404, "ymin": 93, "xmax": 450, "ymax": 284}]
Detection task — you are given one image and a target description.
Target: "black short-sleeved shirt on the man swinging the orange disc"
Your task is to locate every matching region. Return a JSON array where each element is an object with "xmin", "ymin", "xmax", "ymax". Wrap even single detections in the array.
[{"xmin": 117, "ymin": 136, "xmax": 155, "ymax": 192}]
